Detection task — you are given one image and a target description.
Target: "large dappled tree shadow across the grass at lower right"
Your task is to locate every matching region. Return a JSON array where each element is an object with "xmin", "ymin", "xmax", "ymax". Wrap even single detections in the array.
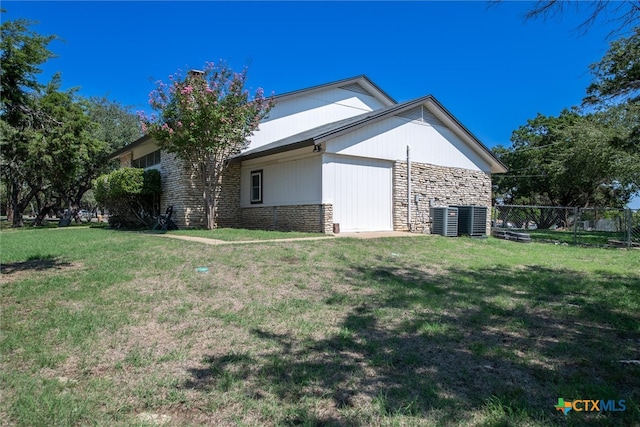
[{"xmin": 185, "ymin": 266, "xmax": 640, "ymax": 426}]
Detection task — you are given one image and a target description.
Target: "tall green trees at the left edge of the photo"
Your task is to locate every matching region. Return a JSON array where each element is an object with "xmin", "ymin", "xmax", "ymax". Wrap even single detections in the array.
[{"xmin": 0, "ymin": 11, "xmax": 142, "ymax": 227}]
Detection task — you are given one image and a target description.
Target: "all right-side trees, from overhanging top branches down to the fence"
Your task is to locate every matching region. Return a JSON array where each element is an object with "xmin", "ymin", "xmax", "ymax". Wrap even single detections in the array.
[{"xmin": 493, "ymin": 1, "xmax": 640, "ymax": 211}]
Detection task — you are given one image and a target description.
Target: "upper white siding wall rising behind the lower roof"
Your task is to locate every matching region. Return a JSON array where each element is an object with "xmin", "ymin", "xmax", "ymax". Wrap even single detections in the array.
[{"xmin": 248, "ymin": 88, "xmax": 384, "ymax": 150}]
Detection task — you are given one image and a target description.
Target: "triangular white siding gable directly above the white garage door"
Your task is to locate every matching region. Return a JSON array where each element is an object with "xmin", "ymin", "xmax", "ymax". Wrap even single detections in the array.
[{"xmin": 326, "ymin": 117, "xmax": 490, "ymax": 171}]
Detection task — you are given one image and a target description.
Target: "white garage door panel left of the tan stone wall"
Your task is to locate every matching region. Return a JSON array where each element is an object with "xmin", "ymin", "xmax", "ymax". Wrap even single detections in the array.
[{"xmin": 325, "ymin": 157, "xmax": 393, "ymax": 231}]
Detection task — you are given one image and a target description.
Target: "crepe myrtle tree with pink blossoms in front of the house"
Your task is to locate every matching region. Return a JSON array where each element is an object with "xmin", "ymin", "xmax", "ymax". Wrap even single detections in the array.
[{"xmin": 139, "ymin": 62, "xmax": 274, "ymax": 229}]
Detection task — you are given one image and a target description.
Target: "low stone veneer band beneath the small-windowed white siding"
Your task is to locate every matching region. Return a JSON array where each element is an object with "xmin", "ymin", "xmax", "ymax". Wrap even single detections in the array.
[{"xmin": 241, "ymin": 204, "xmax": 333, "ymax": 234}]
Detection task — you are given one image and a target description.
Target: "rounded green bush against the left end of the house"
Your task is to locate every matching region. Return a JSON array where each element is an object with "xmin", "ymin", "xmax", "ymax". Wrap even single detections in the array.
[{"xmin": 94, "ymin": 168, "xmax": 161, "ymax": 228}]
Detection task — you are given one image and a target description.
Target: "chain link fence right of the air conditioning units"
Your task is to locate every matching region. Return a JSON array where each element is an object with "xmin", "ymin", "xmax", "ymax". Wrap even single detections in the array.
[{"xmin": 491, "ymin": 205, "xmax": 640, "ymax": 248}]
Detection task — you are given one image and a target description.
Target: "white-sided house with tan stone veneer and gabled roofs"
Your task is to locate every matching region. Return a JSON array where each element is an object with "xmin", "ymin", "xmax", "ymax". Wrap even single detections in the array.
[{"xmin": 113, "ymin": 75, "xmax": 506, "ymax": 233}]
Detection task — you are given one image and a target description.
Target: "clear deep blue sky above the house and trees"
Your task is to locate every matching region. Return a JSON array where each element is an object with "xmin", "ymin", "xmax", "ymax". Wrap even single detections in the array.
[{"xmin": 2, "ymin": 1, "xmax": 640, "ymax": 206}]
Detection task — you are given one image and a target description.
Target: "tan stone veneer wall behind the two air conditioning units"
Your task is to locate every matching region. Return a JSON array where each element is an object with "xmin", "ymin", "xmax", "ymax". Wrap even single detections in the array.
[{"xmin": 393, "ymin": 162, "xmax": 491, "ymax": 233}]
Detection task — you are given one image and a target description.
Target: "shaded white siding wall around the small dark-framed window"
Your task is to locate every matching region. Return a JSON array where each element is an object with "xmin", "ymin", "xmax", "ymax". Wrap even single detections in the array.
[{"xmin": 240, "ymin": 148, "xmax": 322, "ymax": 207}]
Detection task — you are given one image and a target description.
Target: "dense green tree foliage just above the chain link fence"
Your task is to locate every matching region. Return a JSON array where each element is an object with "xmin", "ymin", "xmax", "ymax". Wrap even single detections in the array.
[{"xmin": 494, "ymin": 107, "xmax": 640, "ymax": 211}]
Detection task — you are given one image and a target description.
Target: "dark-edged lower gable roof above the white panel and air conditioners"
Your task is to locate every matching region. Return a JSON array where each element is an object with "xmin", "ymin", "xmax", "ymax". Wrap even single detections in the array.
[{"xmin": 230, "ymin": 95, "xmax": 507, "ymax": 173}]
